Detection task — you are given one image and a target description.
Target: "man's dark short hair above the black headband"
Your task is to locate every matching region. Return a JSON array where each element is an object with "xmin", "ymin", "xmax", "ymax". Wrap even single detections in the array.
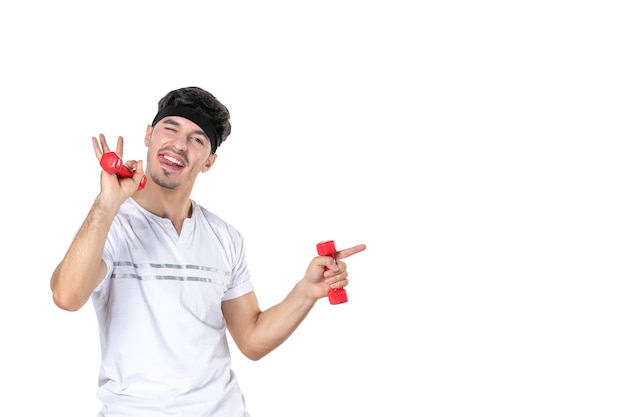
[{"xmin": 158, "ymin": 87, "xmax": 231, "ymax": 153}]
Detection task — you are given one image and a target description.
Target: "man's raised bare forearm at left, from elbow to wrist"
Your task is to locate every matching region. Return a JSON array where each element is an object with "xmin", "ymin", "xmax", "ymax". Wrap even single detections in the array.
[{"xmin": 50, "ymin": 197, "xmax": 117, "ymax": 310}]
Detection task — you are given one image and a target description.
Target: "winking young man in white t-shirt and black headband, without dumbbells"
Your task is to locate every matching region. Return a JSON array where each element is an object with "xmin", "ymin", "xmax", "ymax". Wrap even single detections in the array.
[{"xmin": 51, "ymin": 87, "xmax": 365, "ymax": 417}]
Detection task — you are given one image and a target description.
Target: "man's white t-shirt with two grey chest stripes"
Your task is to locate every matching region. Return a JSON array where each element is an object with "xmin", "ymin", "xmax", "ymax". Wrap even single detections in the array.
[{"xmin": 92, "ymin": 198, "xmax": 253, "ymax": 417}]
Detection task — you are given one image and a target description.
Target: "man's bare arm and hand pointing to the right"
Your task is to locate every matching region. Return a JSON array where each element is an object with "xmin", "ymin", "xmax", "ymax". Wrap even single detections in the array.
[{"xmin": 222, "ymin": 245, "xmax": 365, "ymax": 360}]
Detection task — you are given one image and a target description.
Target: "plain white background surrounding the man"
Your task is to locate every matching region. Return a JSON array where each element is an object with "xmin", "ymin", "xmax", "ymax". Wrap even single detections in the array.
[{"xmin": 0, "ymin": 0, "xmax": 626, "ymax": 417}]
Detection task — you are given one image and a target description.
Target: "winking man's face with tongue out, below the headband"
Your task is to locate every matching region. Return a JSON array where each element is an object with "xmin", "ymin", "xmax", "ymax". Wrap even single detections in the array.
[{"xmin": 145, "ymin": 116, "xmax": 216, "ymax": 190}]
